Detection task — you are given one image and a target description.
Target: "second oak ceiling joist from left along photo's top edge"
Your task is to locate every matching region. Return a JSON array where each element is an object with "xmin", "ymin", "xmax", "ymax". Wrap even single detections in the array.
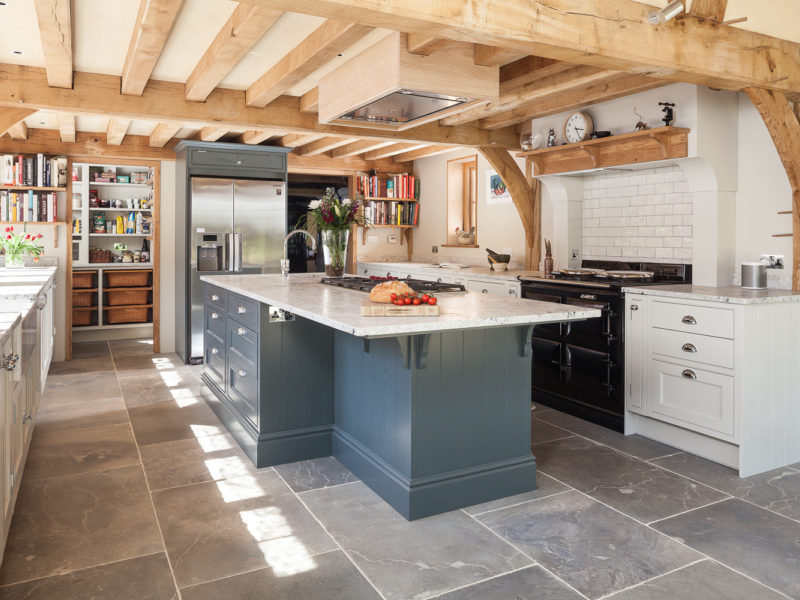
[{"xmin": 121, "ymin": 0, "xmax": 183, "ymax": 96}]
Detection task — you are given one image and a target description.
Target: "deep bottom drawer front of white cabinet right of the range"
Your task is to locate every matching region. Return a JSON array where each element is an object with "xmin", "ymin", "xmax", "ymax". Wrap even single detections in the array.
[{"xmin": 650, "ymin": 359, "xmax": 734, "ymax": 439}]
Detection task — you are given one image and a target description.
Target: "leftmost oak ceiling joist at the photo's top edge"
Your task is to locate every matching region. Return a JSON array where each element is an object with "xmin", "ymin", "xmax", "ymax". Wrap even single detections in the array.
[{"xmin": 33, "ymin": 0, "xmax": 72, "ymax": 88}]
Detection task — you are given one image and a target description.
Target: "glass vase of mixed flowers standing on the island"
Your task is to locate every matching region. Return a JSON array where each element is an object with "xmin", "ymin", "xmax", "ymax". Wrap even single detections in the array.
[{"xmin": 298, "ymin": 188, "xmax": 367, "ymax": 277}]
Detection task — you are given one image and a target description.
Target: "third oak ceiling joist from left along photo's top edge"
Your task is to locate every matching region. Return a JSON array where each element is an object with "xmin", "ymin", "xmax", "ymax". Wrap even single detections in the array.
[{"xmin": 186, "ymin": 4, "xmax": 283, "ymax": 102}]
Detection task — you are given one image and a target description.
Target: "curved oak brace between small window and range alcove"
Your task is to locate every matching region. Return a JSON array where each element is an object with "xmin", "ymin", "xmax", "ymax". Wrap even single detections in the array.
[{"xmin": 478, "ymin": 146, "xmax": 542, "ymax": 269}]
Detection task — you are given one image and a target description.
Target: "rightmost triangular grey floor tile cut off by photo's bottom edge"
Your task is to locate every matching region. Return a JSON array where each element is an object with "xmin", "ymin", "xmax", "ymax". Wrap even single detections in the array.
[{"xmin": 608, "ymin": 560, "xmax": 786, "ymax": 600}]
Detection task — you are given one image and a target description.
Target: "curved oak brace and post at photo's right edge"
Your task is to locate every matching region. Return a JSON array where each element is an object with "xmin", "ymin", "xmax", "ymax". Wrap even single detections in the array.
[{"xmin": 745, "ymin": 88, "xmax": 800, "ymax": 291}]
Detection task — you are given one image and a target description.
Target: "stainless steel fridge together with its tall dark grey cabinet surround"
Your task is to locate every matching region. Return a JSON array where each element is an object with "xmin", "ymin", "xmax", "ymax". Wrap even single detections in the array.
[{"xmin": 175, "ymin": 141, "xmax": 289, "ymax": 363}]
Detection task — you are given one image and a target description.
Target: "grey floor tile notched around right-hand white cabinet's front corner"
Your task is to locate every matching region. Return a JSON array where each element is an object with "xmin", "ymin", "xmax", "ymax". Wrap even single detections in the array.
[{"xmin": 653, "ymin": 452, "xmax": 800, "ymax": 521}]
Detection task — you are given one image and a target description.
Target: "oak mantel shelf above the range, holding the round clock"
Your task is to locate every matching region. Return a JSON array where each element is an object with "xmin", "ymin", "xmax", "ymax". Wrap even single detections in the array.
[{"xmin": 517, "ymin": 127, "xmax": 689, "ymax": 176}]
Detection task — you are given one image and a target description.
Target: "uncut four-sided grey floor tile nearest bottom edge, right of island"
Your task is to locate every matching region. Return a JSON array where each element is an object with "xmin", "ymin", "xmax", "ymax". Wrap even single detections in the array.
[{"xmin": 476, "ymin": 492, "xmax": 700, "ymax": 598}]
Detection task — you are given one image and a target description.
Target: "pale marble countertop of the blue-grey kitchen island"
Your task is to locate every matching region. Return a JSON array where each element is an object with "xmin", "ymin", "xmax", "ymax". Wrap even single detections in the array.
[{"xmin": 200, "ymin": 273, "xmax": 600, "ymax": 337}]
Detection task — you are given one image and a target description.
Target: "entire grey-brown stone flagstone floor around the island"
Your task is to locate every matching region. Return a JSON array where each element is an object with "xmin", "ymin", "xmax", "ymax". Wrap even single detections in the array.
[{"xmin": 0, "ymin": 340, "xmax": 800, "ymax": 600}]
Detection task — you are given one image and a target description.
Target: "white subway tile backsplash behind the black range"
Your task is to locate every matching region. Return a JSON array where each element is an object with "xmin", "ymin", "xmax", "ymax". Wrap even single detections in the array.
[{"xmin": 582, "ymin": 166, "xmax": 692, "ymax": 263}]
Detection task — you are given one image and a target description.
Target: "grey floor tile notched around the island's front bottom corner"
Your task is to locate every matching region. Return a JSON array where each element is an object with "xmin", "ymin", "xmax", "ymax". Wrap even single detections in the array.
[{"xmin": 302, "ymin": 482, "xmax": 531, "ymax": 600}]
